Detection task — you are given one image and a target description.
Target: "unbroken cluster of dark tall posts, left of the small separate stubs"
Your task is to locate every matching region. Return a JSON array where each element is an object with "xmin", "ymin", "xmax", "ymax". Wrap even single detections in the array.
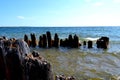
[{"xmin": 24, "ymin": 31, "xmax": 80, "ymax": 48}]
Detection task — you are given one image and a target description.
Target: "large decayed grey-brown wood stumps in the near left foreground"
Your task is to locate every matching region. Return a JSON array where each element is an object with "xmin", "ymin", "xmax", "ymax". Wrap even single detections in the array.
[{"xmin": 0, "ymin": 38, "xmax": 53, "ymax": 80}]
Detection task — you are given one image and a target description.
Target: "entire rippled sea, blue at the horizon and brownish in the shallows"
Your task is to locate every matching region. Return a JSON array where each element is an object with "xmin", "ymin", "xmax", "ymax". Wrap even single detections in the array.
[{"xmin": 0, "ymin": 27, "xmax": 120, "ymax": 80}]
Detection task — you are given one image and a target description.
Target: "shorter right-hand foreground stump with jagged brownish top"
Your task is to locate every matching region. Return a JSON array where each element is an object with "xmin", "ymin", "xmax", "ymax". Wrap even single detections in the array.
[{"xmin": 25, "ymin": 52, "xmax": 53, "ymax": 80}]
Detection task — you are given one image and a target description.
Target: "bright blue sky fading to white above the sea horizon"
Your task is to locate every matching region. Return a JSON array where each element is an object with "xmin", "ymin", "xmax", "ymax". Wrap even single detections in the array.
[{"xmin": 0, "ymin": 0, "xmax": 120, "ymax": 26}]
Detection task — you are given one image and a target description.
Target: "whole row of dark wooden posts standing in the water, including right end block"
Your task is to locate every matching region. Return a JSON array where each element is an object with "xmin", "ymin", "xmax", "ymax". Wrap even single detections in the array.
[{"xmin": 24, "ymin": 31, "xmax": 109, "ymax": 49}]
